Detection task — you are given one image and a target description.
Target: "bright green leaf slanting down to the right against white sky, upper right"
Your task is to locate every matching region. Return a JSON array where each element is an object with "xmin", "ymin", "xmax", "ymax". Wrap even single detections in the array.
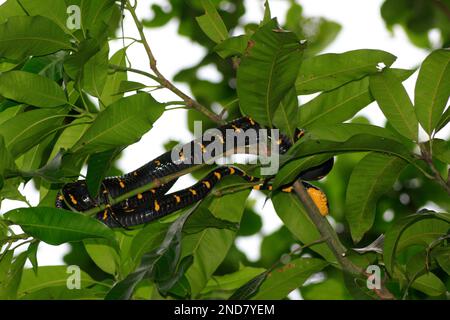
[{"xmin": 370, "ymin": 69, "xmax": 418, "ymax": 141}]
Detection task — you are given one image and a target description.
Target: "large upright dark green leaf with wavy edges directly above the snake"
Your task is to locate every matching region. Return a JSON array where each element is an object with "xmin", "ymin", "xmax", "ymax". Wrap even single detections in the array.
[{"xmin": 237, "ymin": 20, "xmax": 303, "ymax": 126}]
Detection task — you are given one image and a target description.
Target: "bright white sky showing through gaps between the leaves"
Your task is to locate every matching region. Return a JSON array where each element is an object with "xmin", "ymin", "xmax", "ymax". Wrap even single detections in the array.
[{"xmin": 0, "ymin": 0, "xmax": 449, "ymax": 276}]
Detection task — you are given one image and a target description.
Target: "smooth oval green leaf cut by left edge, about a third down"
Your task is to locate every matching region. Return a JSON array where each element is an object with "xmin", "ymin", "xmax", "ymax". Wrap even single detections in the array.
[{"xmin": 0, "ymin": 71, "xmax": 67, "ymax": 108}]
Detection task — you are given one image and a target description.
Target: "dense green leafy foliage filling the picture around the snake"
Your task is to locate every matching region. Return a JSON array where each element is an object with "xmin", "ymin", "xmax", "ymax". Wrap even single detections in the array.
[{"xmin": 0, "ymin": 0, "xmax": 450, "ymax": 299}]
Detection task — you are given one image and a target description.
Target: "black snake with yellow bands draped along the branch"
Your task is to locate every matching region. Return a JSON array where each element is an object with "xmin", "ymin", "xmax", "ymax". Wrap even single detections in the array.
[{"xmin": 56, "ymin": 117, "xmax": 333, "ymax": 228}]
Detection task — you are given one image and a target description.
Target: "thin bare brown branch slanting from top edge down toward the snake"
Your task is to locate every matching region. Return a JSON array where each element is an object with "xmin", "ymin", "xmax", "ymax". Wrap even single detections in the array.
[{"xmin": 126, "ymin": 0, "xmax": 224, "ymax": 124}]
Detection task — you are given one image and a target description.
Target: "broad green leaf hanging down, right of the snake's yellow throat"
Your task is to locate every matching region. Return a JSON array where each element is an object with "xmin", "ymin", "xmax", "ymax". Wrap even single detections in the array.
[{"xmin": 345, "ymin": 152, "xmax": 407, "ymax": 243}]
